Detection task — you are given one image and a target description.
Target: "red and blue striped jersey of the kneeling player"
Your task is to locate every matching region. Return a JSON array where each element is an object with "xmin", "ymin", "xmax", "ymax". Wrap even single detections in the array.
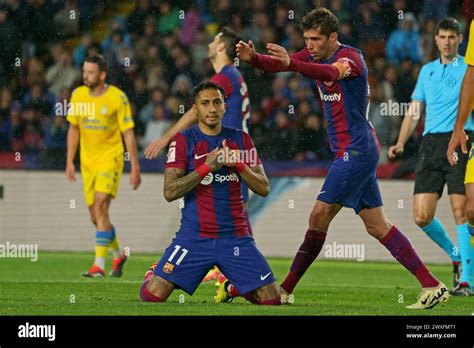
[{"xmin": 166, "ymin": 125, "xmax": 261, "ymax": 238}]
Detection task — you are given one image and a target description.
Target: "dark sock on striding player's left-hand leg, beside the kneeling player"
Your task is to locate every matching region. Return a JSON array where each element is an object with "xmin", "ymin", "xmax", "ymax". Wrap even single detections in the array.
[{"xmin": 281, "ymin": 230, "xmax": 327, "ymax": 294}]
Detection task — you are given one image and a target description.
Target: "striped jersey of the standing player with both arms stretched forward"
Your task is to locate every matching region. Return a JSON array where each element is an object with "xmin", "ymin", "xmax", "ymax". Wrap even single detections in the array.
[{"xmin": 250, "ymin": 45, "xmax": 380, "ymax": 158}]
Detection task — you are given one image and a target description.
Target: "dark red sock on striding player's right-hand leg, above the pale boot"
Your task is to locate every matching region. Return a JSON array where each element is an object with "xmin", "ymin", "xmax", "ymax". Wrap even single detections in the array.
[{"xmin": 380, "ymin": 226, "xmax": 439, "ymax": 288}]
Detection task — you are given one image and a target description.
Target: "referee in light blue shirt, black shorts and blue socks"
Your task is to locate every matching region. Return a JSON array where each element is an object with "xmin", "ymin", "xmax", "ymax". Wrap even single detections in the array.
[{"xmin": 388, "ymin": 18, "xmax": 474, "ymax": 295}]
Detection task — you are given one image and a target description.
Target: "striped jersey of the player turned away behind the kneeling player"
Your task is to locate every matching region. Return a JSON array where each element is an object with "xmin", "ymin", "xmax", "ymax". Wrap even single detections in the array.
[{"xmin": 211, "ymin": 64, "xmax": 250, "ymax": 132}]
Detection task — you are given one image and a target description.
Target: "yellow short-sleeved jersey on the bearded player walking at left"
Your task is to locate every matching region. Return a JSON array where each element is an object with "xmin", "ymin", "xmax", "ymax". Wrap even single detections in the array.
[{"xmin": 67, "ymin": 85, "xmax": 134, "ymax": 167}]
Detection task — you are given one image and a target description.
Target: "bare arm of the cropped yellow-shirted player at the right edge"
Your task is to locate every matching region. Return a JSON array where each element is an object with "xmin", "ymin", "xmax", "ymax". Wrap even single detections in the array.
[{"xmin": 446, "ymin": 65, "xmax": 474, "ymax": 166}]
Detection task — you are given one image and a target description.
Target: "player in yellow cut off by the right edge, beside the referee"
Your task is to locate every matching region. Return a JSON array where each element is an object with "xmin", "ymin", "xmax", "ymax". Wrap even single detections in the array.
[{"xmin": 446, "ymin": 21, "xmax": 474, "ymax": 296}]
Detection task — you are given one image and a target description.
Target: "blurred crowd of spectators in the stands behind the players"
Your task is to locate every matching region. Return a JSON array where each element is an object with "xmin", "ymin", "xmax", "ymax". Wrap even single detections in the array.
[{"xmin": 0, "ymin": 0, "xmax": 473, "ymax": 177}]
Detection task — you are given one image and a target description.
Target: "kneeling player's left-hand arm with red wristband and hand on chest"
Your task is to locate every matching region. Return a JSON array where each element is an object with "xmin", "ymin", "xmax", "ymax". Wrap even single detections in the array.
[{"xmin": 163, "ymin": 148, "xmax": 222, "ymax": 202}]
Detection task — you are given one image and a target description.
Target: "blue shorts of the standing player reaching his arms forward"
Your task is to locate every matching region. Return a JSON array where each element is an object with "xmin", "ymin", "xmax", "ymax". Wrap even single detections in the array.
[{"xmin": 317, "ymin": 156, "xmax": 383, "ymax": 214}]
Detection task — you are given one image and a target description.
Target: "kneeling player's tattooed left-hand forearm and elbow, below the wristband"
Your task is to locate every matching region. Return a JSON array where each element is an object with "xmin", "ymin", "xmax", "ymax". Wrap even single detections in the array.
[{"xmin": 163, "ymin": 168, "xmax": 202, "ymax": 202}]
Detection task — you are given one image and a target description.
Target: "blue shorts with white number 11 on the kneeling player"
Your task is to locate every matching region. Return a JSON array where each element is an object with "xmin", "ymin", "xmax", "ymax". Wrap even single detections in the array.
[{"xmin": 154, "ymin": 233, "xmax": 275, "ymax": 295}]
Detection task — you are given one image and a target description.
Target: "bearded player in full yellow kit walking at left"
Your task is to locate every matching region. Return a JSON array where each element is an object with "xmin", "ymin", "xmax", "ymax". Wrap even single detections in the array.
[{"xmin": 66, "ymin": 56, "xmax": 141, "ymax": 277}]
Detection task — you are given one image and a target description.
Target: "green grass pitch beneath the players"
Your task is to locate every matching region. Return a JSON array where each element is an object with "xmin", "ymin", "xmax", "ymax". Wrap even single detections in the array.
[{"xmin": 0, "ymin": 252, "xmax": 474, "ymax": 316}]
